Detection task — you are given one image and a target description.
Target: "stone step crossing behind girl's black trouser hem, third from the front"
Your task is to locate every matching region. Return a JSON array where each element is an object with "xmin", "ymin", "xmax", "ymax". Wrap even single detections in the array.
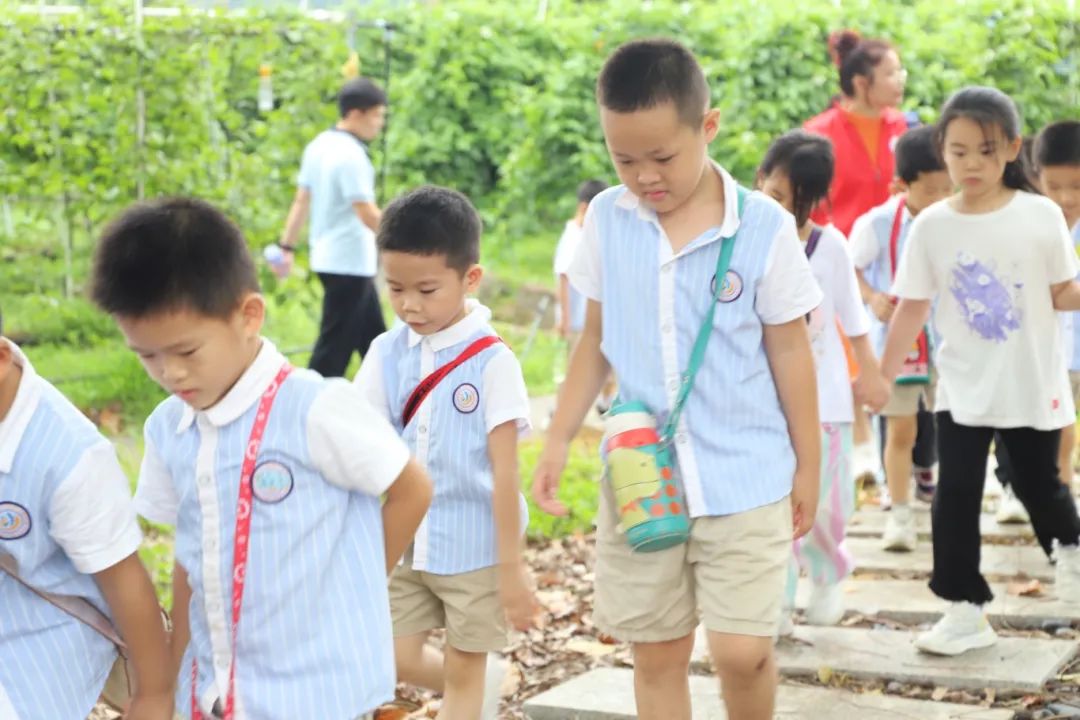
[{"xmin": 795, "ymin": 578, "xmax": 1080, "ymax": 629}]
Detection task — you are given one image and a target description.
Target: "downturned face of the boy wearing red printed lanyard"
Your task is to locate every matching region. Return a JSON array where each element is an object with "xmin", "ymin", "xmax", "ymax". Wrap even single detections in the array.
[{"xmin": 116, "ymin": 293, "xmax": 266, "ymax": 410}]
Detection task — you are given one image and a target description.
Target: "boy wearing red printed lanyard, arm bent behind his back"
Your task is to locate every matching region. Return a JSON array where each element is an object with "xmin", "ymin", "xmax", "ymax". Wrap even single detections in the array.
[{"xmin": 93, "ymin": 199, "xmax": 431, "ymax": 720}]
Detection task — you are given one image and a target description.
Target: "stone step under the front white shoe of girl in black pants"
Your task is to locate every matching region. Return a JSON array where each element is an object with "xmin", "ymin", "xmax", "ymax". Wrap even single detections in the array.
[{"xmin": 777, "ymin": 625, "xmax": 1078, "ymax": 692}]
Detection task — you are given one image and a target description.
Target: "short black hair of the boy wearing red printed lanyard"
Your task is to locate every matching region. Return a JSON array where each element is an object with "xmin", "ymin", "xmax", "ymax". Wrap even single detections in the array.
[{"xmin": 91, "ymin": 198, "xmax": 259, "ymax": 317}]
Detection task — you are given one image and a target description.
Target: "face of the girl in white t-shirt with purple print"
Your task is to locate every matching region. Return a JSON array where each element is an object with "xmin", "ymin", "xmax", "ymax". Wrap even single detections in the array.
[{"xmin": 943, "ymin": 118, "xmax": 1022, "ymax": 199}]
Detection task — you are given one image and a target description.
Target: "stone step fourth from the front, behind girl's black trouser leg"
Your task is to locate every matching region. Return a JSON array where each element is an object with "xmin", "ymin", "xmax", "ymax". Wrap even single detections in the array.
[{"xmin": 847, "ymin": 538, "xmax": 1054, "ymax": 581}]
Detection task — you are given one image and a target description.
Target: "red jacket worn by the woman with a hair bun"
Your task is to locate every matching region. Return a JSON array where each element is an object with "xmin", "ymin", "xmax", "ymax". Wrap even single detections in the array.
[{"xmin": 804, "ymin": 107, "xmax": 907, "ymax": 235}]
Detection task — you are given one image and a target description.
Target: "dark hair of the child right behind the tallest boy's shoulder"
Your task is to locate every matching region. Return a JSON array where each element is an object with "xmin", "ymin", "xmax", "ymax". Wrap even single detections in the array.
[{"xmin": 758, "ymin": 130, "xmax": 835, "ymax": 228}]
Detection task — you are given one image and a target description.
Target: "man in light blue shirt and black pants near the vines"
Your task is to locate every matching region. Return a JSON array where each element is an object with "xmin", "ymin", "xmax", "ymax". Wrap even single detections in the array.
[{"xmin": 279, "ymin": 78, "xmax": 387, "ymax": 377}]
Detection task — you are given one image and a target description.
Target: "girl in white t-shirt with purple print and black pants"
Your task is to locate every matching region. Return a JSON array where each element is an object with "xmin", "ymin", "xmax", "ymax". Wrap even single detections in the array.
[{"xmin": 881, "ymin": 87, "xmax": 1080, "ymax": 655}]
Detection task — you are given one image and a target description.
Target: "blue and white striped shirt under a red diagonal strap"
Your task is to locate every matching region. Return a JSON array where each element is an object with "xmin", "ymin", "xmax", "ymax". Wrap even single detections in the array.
[{"xmin": 355, "ymin": 301, "xmax": 529, "ymax": 575}]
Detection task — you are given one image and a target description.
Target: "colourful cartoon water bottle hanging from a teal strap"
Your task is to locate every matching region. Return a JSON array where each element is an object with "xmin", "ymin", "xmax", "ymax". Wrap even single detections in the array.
[{"xmin": 603, "ymin": 403, "xmax": 690, "ymax": 553}]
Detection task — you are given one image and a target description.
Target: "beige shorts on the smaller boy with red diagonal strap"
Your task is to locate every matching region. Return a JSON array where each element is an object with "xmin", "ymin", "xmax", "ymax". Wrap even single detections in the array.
[{"xmin": 390, "ymin": 566, "xmax": 507, "ymax": 652}]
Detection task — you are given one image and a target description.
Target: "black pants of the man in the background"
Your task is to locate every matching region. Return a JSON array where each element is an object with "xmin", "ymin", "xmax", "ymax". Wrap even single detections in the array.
[{"xmin": 308, "ymin": 272, "xmax": 387, "ymax": 378}]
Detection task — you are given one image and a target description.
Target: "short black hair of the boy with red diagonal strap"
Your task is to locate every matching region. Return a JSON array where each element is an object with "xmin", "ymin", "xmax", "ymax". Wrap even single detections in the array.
[{"xmin": 376, "ymin": 185, "xmax": 481, "ymax": 272}]
